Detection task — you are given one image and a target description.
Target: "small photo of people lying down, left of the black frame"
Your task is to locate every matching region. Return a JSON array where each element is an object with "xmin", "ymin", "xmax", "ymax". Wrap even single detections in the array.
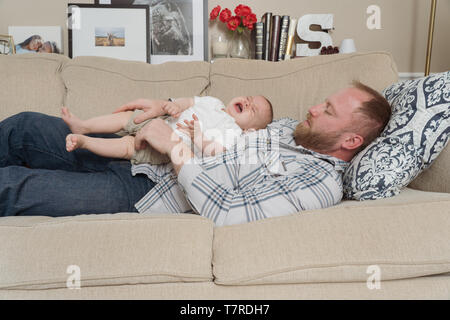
[{"xmin": 8, "ymin": 26, "xmax": 63, "ymax": 54}]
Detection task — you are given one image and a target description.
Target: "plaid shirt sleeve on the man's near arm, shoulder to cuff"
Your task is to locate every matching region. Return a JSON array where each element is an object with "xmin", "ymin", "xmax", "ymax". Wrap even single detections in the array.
[{"xmin": 178, "ymin": 162, "xmax": 342, "ymax": 226}]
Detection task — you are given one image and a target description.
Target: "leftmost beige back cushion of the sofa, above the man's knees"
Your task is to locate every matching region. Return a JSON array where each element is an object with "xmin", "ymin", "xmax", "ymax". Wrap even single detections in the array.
[{"xmin": 0, "ymin": 53, "xmax": 69, "ymax": 120}]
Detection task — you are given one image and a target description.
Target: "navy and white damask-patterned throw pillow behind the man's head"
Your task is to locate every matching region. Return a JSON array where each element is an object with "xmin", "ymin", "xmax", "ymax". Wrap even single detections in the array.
[{"xmin": 344, "ymin": 71, "xmax": 450, "ymax": 200}]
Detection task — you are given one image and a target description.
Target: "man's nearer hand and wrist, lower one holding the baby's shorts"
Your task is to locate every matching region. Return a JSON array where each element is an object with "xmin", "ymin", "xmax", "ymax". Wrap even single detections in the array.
[{"xmin": 134, "ymin": 119, "xmax": 194, "ymax": 173}]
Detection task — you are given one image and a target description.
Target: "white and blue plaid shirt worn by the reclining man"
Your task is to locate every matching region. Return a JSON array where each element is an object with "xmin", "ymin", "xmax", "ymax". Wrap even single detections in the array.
[{"xmin": 132, "ymin": 118, "xmax": 348, "ymax": 226}]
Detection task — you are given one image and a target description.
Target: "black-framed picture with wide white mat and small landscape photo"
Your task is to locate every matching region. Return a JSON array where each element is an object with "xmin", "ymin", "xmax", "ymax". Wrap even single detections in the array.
[{"xmin": 68, "ymin": 3, "xmax": 150, "ymax": 63}]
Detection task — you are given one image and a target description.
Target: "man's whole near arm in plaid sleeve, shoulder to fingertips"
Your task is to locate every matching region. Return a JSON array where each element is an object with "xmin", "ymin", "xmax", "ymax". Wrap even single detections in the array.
[{"xmin": 136, "ymin": 119, "xmax": 342, "ymax": 226}]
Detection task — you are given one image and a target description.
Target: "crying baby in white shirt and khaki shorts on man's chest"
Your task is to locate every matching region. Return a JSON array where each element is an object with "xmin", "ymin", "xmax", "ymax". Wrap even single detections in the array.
[{"xmin": 62, "ymin": 96, "xmax": 273, "ymax": 164}]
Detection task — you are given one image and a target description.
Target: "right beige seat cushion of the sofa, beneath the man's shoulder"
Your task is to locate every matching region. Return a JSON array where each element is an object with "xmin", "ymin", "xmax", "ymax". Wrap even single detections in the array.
[{"xmin": 213, "ymin": 198, "xmax": 450, "ymax": 285}]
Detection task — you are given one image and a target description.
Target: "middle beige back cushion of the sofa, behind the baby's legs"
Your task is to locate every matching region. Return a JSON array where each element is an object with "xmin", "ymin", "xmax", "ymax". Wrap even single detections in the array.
[{"xmin": 61, "ymin": 57, "xmax": 209, "ymax": 118}]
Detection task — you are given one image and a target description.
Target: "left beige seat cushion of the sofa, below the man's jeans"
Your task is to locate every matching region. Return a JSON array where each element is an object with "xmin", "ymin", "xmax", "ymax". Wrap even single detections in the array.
[{"xmin": 0, "ymin": 213, "xmax": 213, "ymax": 289}]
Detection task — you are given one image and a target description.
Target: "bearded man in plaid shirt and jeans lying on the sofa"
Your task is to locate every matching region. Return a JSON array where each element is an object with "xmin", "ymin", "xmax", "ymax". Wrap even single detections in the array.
[{"xmin": 0, "ymin": 83, "xmax": 390, "ymax": 226}]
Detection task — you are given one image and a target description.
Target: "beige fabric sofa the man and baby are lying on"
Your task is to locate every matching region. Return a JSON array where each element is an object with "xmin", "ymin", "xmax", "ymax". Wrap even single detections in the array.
[{"xmin": 0, "ymin": 52, "xmax": 450, "ymax": 299}]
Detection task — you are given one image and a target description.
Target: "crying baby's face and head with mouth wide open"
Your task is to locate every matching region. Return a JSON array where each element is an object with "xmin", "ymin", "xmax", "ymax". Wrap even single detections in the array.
[{"xmin": 225, "ymin": 96, "xmax": 272, "ymax": 130}]
